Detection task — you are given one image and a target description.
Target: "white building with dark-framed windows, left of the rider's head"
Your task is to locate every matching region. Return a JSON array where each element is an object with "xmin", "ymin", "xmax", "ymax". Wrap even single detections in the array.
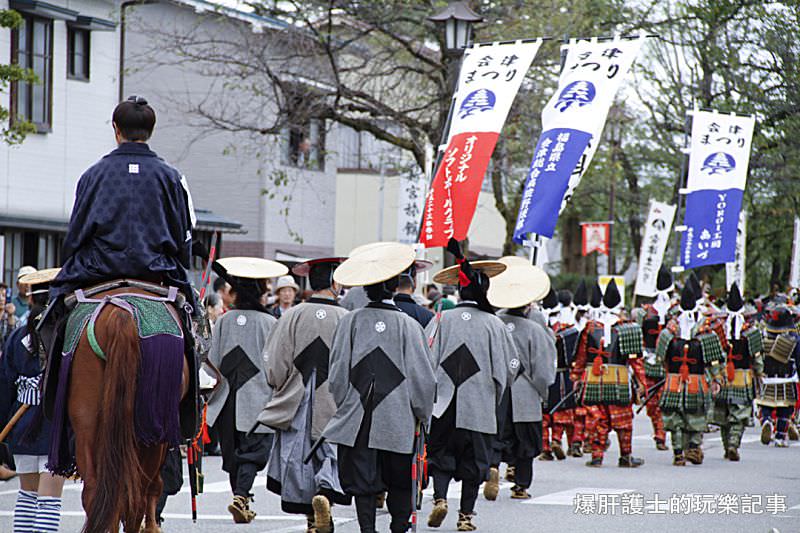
[{"xmin": 0, "ymin": 0, "xmax": 119, "ymax": 283}]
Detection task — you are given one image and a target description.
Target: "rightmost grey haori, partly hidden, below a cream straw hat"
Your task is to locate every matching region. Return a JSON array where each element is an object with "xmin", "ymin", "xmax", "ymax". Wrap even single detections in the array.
[{"xmin": 498, "ymin": 311, "xmax": 556, "ymax": 422}]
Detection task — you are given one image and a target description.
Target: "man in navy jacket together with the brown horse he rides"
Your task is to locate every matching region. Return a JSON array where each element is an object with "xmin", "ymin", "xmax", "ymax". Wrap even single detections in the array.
[{"xmin": 43, "ymin": 96, "xmax": 202, "ymax": 531}]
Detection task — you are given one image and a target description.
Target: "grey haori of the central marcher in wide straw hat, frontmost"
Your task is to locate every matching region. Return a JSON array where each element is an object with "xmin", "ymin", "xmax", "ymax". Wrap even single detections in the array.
[{"xmin": 324, "ymin": 302, "xmax": 436, "ymax": 454}]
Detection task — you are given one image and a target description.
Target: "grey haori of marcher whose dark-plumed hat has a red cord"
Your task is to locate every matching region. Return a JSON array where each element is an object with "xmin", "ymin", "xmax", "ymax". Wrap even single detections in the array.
[{"xmin": 427, "ymin": 303, "xmax": 519, "ymax": 435}]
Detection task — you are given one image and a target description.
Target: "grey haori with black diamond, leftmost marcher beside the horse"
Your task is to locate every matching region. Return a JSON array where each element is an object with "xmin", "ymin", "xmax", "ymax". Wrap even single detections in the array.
[{"xmin": 207, "ymin": 309, "xmax": 277, "ymax": 433}]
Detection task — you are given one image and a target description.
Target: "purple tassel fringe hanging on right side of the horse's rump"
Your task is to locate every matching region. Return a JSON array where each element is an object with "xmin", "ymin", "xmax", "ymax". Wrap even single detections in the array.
[{"xmin": 134, "ymin": 334, "xmax": 184, "ymax": 446}]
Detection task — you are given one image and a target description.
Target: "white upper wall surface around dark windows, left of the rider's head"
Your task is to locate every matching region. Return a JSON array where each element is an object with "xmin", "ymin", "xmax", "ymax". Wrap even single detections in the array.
[{"xmin": 0, "ymin": 0, "xmax": 119, "ymax": 220}]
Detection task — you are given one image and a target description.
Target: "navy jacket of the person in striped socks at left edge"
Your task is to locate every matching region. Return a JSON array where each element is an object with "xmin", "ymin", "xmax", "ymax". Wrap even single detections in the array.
[{"xmin": 0, "ymin": 327, "xmax": 50, "ymax": 455}]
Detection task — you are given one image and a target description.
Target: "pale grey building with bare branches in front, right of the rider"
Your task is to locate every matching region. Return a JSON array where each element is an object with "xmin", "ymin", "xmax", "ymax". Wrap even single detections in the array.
[{"xmin": 123, "ymin": 0, "xmax": 336, "ymax": 259}]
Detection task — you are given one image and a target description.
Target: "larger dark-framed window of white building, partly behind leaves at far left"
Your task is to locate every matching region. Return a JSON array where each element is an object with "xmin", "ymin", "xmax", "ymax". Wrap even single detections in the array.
[{"xmin": 11, "ymin": 15, "xmax": 53, "ymax": 133}]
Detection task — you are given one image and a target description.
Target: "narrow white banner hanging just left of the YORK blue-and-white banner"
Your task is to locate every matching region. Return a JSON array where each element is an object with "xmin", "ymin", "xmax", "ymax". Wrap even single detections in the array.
[{"xmin": 635, "ymin": 200, "xmax": 676, "ymax": 296}]
